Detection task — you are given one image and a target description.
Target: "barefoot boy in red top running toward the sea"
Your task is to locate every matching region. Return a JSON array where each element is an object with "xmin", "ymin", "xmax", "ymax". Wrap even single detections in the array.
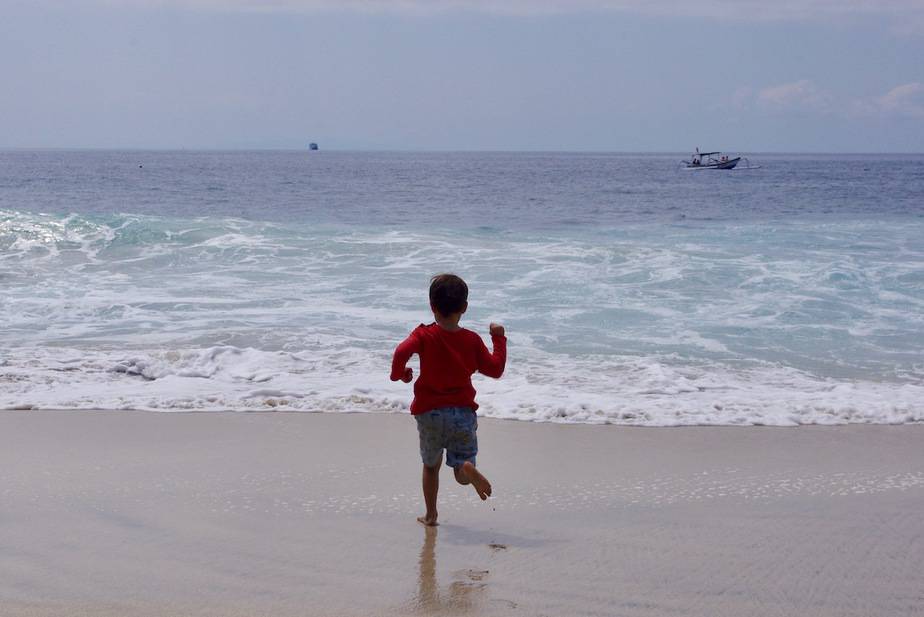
[{"xmin": 391, "ymin": 274, "xmax": 507, "ymax": 526}]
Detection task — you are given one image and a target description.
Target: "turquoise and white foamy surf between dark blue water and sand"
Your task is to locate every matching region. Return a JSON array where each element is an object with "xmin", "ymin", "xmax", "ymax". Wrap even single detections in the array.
[{"xmin": 0, "ymin": 211, "xmax": 924, "ymax": 426}]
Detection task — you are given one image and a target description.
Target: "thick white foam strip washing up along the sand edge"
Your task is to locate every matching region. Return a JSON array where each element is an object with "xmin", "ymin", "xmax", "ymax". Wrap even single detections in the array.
[{"xmin": 0, "ymin": 344, "xmax": 924, "ymax": 426}]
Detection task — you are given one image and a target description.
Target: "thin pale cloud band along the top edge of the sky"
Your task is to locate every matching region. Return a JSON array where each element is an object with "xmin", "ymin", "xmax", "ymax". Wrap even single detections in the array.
[{"xmin": 97, "ymin": 0, "xmax": 924, "ymax": 23}]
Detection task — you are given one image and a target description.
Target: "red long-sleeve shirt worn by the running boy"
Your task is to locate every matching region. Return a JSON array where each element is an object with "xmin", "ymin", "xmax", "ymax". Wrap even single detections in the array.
[{"xmin": 391, "ymin": 323, "xmax": 507, "ymax": 415}]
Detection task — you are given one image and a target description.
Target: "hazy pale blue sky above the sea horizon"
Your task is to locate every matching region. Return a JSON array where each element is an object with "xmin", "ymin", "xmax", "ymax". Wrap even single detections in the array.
[{"xmin": 0, "ymin": 0, "xmax": 924, "ymax": 152}]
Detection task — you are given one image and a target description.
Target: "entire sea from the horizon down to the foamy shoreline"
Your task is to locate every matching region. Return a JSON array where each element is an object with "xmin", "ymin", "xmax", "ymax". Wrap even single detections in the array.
[{"xmin": 0, "ymin": 151, "xmax": 924, "ymax": 426}]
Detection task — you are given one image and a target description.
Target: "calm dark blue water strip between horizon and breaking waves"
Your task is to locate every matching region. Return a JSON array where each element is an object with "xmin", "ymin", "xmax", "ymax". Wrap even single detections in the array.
[{"xmin": 0, "ymin": 151, "xmax": 924, "ymax": 231}]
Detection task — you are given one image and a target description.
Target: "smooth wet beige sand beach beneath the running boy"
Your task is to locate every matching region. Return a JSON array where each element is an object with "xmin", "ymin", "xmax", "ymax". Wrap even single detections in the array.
[{"xmin": 0, "ymin": 411, "xmax": 924, "ymax": 617}]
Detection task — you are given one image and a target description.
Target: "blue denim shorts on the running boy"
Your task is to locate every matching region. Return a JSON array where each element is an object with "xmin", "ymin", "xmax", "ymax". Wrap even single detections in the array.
[{"xmin": 414, "ymin": 407, "xmax": 478, "ymax": 468}]
